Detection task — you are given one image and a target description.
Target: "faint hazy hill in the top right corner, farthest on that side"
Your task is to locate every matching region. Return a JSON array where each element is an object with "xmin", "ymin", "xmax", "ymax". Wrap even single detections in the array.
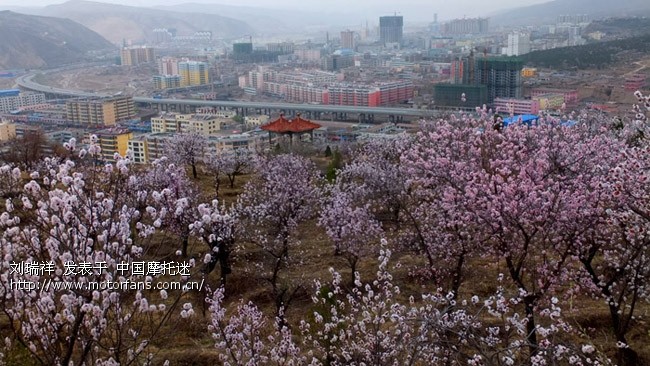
[{"xmin": 490, "ymin": 0, "xmax": 650, "ymax": 27}]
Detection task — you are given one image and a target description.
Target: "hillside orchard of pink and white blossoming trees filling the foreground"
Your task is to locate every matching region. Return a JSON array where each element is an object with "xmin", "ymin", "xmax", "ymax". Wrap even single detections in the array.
[{"xmin": 0, "ymin": 93, "xmax": 650, "ymax": 365}]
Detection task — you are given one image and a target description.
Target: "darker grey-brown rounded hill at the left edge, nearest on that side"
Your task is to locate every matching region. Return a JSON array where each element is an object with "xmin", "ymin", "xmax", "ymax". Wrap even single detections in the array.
[{"xmin": 0, "ymin": 11, "xmax": 114, "ymax": 69}]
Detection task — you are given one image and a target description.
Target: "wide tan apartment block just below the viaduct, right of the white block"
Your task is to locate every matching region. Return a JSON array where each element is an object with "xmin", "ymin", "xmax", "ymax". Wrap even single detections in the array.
[{"xmin": 65, "ymin": 97, "xmax": 136, "ymax": 126}]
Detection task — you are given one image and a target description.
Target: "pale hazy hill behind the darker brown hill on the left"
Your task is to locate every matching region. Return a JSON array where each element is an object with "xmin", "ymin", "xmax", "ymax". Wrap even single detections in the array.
[{"xmin": 30, "ymin": 0, "xmax": 253, "ymax": 44}]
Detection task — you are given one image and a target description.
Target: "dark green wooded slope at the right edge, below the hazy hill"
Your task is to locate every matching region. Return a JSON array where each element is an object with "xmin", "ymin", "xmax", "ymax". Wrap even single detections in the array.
[{"xmin": 520, "ymin": 34, "xmax": 650, "ymax": 69}]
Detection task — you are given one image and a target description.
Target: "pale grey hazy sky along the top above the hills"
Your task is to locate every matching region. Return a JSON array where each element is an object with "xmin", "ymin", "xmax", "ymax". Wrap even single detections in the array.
[{"xmin": 0, "ymin": 0, "xmax": 550, "ymax": 22}]
